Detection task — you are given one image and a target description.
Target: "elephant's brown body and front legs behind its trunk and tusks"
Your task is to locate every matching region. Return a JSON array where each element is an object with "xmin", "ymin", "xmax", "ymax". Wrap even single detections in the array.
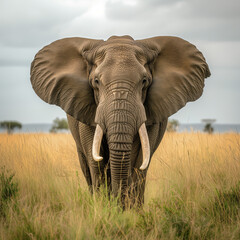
[{"xmin": 67, "ymin": 115, "xmax": 167, "ymax": 205}]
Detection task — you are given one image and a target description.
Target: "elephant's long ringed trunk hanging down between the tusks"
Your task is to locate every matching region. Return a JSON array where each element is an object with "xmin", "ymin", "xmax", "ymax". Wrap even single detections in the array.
[{"xmin": 105, "ymin": 94, "xmax": 145, "ymax": 199}]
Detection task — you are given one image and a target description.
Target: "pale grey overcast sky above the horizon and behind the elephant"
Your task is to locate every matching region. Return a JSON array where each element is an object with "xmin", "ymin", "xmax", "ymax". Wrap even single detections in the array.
[{"xmin": 0, "ymin": 0, "xmax": 240, "ymax": 123}]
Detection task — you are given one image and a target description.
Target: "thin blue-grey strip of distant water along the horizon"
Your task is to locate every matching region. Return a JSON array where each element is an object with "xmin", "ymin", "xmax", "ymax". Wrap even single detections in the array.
[{"xmin": 0, "ymin": 123, "xmax": 240, "ymax": 133}]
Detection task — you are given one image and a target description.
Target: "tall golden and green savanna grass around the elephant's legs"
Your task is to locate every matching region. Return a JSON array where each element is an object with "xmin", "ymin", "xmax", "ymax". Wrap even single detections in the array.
[{"xmin": 0, "ymin": 133, "xmax": 240, "ymax": 240}]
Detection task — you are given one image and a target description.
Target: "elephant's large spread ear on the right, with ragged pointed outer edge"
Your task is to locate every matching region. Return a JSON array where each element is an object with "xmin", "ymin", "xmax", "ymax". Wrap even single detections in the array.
[{"xmin": 139, "ymin": 37, "xmax": 210, "ymax": 124}]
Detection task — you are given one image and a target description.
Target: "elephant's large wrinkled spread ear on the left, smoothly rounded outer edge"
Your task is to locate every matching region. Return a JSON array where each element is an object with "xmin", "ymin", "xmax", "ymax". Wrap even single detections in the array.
[{"xmin": 31, "ymin": 38, "xmax": 102, "ymax": 125}]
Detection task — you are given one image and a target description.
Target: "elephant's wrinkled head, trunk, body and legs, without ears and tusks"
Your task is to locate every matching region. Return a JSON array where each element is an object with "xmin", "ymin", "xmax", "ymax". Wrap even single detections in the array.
[{"xmin": 68, "ymin": 41, "xmax": 167, "ymax": 204}]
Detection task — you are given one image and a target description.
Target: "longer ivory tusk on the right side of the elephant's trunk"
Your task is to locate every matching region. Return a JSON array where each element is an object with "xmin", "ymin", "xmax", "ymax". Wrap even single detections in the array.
[{"xmin": 138, "ymin": 123, "xmax": 150, "ymax": 170}]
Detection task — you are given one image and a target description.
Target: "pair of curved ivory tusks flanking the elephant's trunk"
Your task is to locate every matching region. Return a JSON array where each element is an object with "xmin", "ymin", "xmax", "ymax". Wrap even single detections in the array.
[{"xmin": 92, "ymin": 123, "xmax": 150, "ymax": 170}]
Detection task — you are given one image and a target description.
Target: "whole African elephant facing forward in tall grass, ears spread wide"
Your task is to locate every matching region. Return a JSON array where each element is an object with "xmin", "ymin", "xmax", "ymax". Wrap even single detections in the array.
[{"xmin": 31, "ymin": 36, "xmax": 210, "ymax": 205}]
